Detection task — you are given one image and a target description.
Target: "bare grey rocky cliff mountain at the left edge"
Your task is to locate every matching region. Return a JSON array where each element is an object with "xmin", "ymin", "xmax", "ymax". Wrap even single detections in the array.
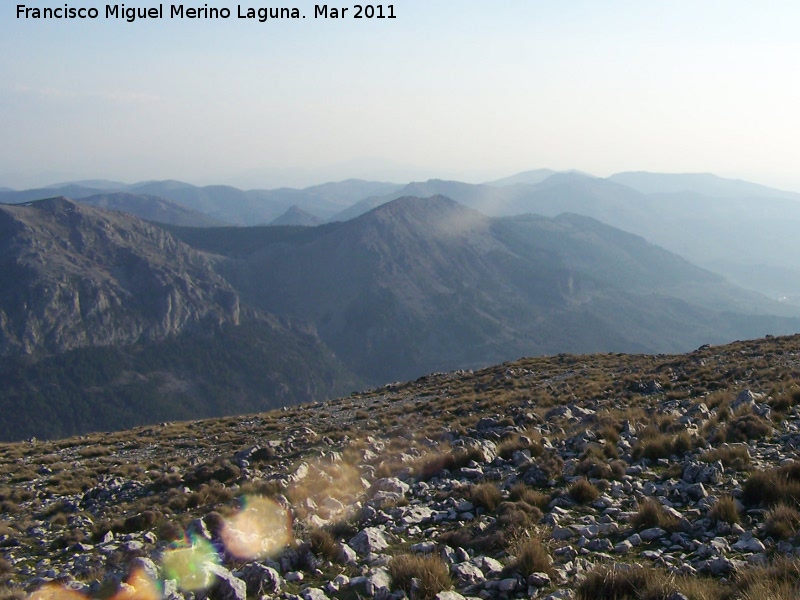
[{"xmin": 0, "ymin": 198, "xmax": 240, "ymax": 356}]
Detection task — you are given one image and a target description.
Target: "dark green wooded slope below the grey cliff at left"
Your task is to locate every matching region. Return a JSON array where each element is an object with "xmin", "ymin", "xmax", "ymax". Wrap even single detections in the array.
[{"xmin": 0, "ymin": 321, "xmax": 359, "ymax": 440}]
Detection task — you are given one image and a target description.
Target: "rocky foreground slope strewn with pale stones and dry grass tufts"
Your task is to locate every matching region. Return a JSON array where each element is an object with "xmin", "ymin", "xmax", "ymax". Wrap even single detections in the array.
[{"xmin": 0, "ymin": 337, "xmax": 800, "ymax": 600}]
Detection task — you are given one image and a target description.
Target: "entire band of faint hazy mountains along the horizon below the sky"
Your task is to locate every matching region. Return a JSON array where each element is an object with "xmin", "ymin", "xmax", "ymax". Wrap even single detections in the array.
[{"xmin": 0, "ymin": 169, "xmax": 800, "ymax": 305}]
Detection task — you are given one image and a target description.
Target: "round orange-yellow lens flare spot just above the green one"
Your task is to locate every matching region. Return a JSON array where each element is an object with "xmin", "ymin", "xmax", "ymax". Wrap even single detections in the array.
[{"xmin": 221, "ymin": 496, "xmax": 292, "ymax": 560}]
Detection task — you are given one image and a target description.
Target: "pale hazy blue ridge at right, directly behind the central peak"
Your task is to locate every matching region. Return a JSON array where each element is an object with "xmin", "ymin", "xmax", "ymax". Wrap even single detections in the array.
[{"xmin": 328, "ymin": 173, "xmax": 800, "ymax": 305}]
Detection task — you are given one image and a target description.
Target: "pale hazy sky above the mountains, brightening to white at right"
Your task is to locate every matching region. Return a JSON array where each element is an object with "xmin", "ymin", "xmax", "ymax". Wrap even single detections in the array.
[{"xmin": 0, "ymin": 0, "xmax": 800, "ymax": 190}]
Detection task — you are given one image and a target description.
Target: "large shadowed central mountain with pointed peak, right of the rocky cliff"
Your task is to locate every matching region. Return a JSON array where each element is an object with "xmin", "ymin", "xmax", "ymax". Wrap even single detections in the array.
[{"xmin": 173, "ymin": 196, "xmax": 800, "ymax": 383}]
